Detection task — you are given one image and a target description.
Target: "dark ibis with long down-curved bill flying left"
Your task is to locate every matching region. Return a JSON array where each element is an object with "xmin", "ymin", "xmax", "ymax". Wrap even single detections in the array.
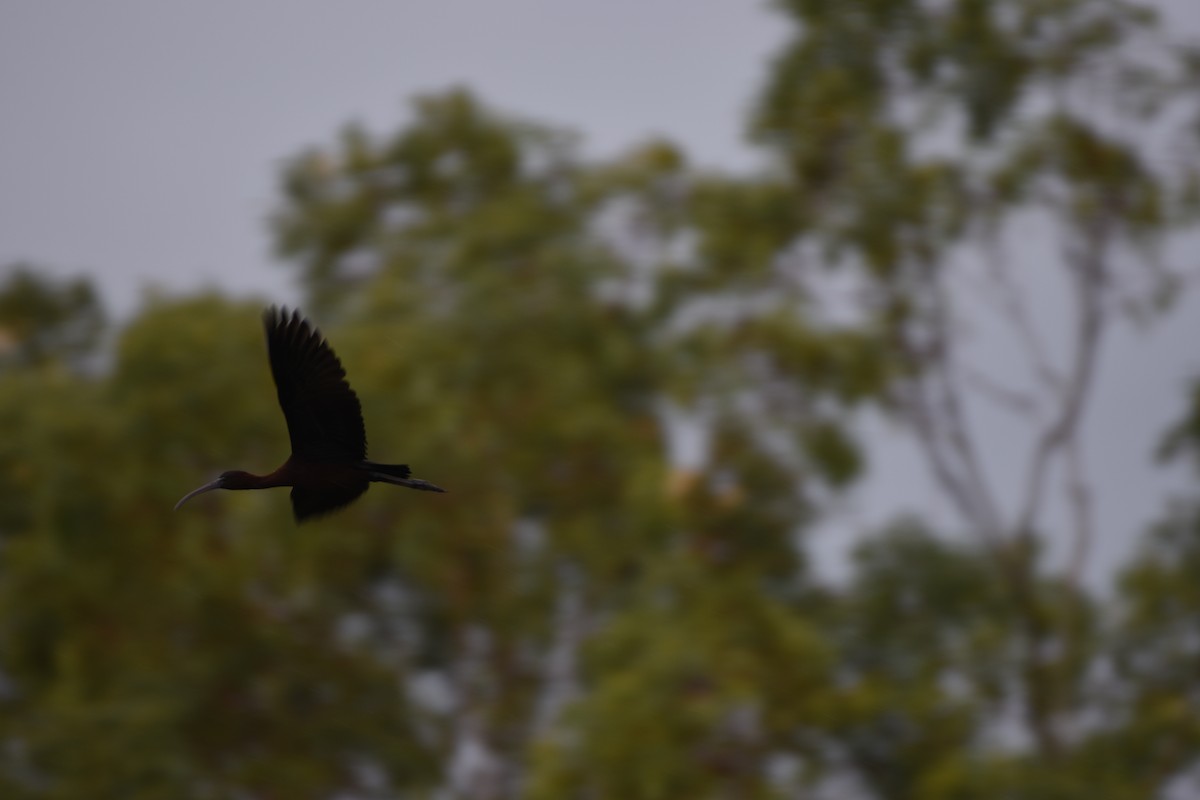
[{"xmin": 175, "ymin": 306, "xmax": 445, "ymax": 523}]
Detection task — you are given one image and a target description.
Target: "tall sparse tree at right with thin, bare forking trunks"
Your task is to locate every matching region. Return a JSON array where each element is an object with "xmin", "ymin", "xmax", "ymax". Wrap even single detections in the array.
[{"xmin": 751, "ymin": 0, "xmax": 1196, "ymax": 782}]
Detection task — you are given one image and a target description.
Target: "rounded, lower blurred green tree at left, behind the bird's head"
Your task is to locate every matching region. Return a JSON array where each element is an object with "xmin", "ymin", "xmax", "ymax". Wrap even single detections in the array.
[{"xmin": 0, "ymin": 296, "xmax": 441, "ymax": 798}]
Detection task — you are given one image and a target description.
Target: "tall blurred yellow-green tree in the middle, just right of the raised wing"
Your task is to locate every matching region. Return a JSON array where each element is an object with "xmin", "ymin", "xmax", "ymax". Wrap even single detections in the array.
[{"xmin": 277, "ymin": 92, "xmax": 868, "ymax": 796}]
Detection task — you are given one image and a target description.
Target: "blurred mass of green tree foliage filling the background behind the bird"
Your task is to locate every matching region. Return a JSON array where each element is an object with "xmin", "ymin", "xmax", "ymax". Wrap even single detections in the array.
[{"xmin": 0, "ymin": 0, "xmax": 1200, "ymax": 800}]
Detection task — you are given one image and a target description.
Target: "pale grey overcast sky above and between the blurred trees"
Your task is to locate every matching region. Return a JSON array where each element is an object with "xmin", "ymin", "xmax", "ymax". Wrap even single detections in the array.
[{"xmin": 0, "ymin": 0, "xmax": 1200, "ymax": 582}]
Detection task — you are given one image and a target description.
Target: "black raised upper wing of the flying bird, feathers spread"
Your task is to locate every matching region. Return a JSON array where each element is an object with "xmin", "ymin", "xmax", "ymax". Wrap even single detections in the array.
[{"xmin": 263, "ymin": 306, "xmax": 367, "ymax": 462}]
